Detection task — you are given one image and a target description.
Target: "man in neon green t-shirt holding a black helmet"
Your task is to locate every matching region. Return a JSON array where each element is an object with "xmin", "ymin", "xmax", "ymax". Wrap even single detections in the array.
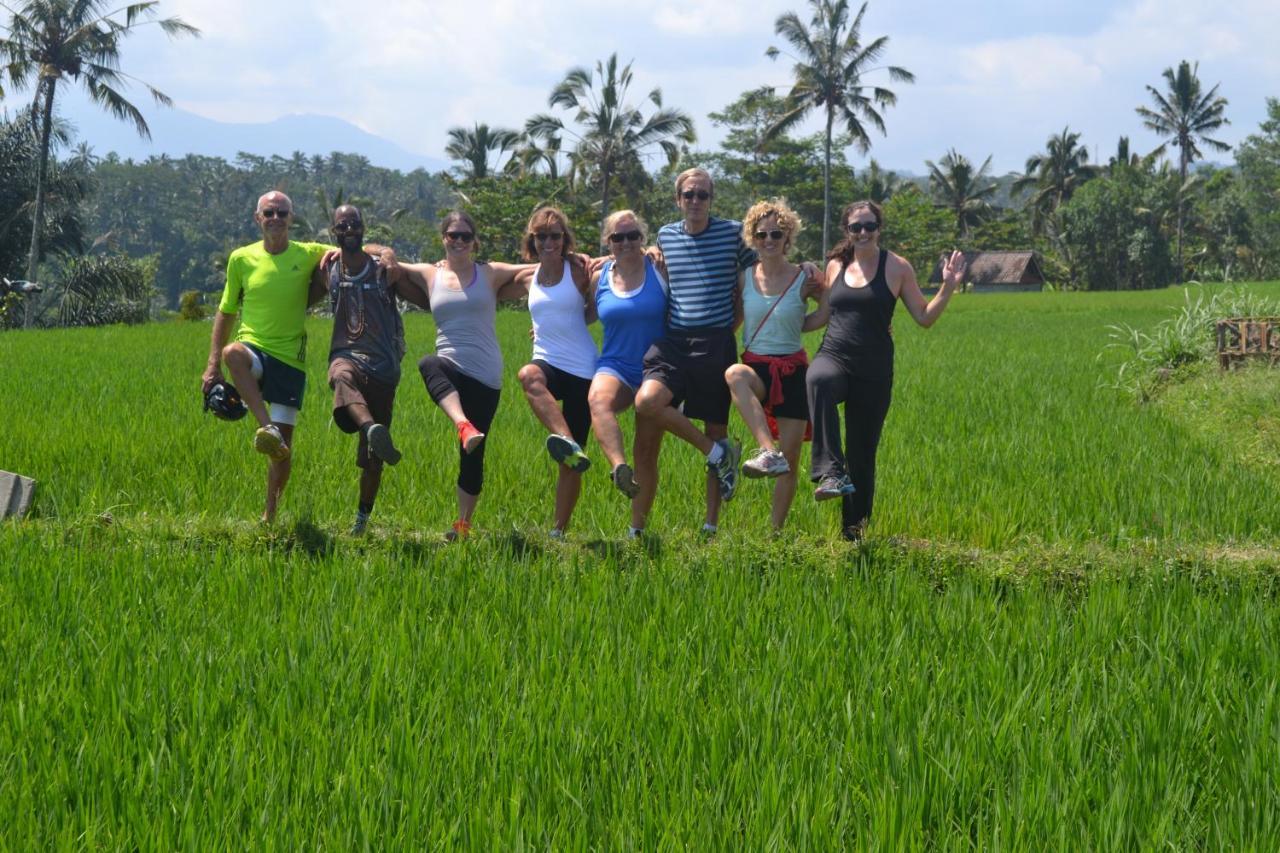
[{"xmin": 201, "ymin": 192, "xmax": 332, "ymax": 523}]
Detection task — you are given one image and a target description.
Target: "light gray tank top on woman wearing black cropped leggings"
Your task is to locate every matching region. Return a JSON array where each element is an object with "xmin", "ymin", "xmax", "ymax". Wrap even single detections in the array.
[{"xmin": 430, "ymin": 264, "xmax": 502, "ymax": 391}]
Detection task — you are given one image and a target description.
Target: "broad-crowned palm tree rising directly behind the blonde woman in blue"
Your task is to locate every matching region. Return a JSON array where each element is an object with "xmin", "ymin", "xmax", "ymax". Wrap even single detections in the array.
[{"xmin": 525, "ymin": 54, "xmax": 695, "ymax": 216}]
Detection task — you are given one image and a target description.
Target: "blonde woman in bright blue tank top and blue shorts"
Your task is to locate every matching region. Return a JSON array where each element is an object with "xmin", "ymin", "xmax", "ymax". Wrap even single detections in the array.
[{"xmin": 588, "ymin": 210, "xmax": 667, "ymax": 535}]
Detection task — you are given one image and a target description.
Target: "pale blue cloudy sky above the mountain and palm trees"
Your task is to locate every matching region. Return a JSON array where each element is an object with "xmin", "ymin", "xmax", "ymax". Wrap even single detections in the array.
[{"xmin": 6, "ymin": 0, "xmax": 1280, "ymax": 173}]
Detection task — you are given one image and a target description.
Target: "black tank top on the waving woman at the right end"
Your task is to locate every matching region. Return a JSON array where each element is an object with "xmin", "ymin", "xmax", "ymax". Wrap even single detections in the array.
[{"xmin": 818, "ymin": 248, "xmax": 897, "ymax": 379}]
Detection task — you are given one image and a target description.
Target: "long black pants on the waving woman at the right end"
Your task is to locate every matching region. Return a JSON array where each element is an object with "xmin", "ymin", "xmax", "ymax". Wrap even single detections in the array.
[{"xmin": 806, "ymin": 352, "xmax": 893, "ymax": 528}]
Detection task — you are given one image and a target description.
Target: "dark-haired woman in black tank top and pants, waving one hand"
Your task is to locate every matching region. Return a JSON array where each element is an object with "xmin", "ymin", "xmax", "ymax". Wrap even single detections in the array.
[{"xmin": 806, "ymin": 201, "xmax": 965, "ymax": 540}]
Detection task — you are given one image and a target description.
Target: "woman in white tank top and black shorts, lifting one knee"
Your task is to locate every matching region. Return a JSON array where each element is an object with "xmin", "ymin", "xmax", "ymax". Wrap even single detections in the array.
[{"xmin": 517, "ymin": 206, "xmax": 596, "ymax": 538}]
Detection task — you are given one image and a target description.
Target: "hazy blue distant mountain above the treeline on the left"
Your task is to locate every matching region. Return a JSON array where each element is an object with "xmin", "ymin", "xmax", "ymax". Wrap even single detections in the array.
[{"xmin": 63, "ymin": 102, "xmax": 449, "ymax": 172}]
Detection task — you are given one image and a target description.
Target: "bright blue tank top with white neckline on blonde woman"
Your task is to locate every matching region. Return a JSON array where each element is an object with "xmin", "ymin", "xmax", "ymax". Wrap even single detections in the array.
[{"xmin": 595, "ymin": 257, "xmax": 667, "ymax": 388}]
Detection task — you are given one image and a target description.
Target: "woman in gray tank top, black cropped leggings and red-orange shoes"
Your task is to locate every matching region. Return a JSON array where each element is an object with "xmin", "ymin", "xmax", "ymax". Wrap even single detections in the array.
[{"xmin": 386, "ymin": 210, "xmax": 530, "ymax": 540}]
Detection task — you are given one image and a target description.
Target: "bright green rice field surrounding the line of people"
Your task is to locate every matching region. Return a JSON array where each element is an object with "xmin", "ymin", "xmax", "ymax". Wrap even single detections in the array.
[{"xmin": 0, "ymin": 283, "xmax": 1280, "ymax": 849}]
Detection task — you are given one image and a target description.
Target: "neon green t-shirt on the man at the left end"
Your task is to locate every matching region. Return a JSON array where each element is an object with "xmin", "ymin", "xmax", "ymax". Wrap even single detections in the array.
[{"xmin": 218, "ymin": 241, "xmax": 333, "ymax": 370}]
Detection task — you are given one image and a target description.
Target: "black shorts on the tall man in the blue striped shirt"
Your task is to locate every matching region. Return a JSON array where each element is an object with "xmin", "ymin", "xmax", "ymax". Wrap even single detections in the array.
[{"xmin": 644, "ymin": 329, "xmax": 737, "ymax": 424}]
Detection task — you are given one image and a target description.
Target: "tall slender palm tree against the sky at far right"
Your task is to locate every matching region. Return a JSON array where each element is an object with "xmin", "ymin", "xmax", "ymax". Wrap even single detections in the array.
[{"xmin": 1138, "ymin": 59, "xmax": 1231, "ymax": 282}]
